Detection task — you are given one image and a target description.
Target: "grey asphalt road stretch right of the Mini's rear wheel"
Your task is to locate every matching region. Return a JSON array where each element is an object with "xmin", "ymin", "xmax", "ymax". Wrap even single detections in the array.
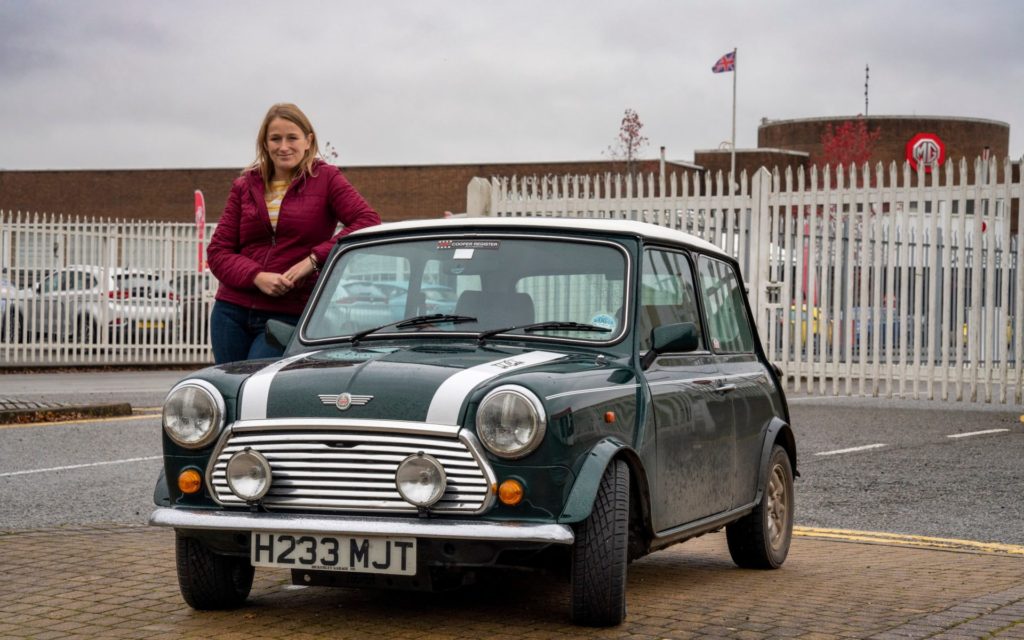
[{"xmin": 791, "ymin": 398, "xmax": 1024, "ymax": 545}]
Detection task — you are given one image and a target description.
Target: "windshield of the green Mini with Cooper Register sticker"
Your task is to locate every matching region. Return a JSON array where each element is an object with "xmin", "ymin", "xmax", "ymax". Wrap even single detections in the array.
[{"xmin": 302, "ymin": 236, "xmax": 627, "ymax": 342}]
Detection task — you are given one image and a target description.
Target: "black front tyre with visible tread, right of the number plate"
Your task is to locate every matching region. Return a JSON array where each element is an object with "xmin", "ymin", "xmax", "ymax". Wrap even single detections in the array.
[{"xmin": 571, "ymin": 460, "xmax": 630, "ymax": 627}]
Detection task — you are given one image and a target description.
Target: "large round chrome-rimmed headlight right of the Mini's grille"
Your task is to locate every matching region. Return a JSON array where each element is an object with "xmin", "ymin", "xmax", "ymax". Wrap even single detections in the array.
[{"xmin": 476, "ymin": 386, "xmax": 547, "ymax": 459}]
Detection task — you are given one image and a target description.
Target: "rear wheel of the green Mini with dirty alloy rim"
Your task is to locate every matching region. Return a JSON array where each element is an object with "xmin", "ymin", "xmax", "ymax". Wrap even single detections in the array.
[{"xmin": 725, "ymin": 444, "xmax": 794, "ymax": 569}]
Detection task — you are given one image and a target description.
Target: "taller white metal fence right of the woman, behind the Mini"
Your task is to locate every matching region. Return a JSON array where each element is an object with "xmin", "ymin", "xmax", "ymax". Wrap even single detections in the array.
[{"xmin": 481, "ymin": 160, "xmax": 1024, "ymax": 403}]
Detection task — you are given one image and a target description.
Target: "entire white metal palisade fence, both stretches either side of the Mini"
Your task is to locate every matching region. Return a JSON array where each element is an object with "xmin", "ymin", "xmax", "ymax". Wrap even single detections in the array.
[{"xmin": 0, "ymin": 161, "xmax": 1024, "ymax": 403}]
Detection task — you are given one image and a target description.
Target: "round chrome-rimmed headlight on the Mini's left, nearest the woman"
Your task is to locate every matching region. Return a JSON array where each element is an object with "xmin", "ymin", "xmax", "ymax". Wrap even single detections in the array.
[{"xmin": 163, "ymin": 380, "xmax": 224, "ymax": 449}]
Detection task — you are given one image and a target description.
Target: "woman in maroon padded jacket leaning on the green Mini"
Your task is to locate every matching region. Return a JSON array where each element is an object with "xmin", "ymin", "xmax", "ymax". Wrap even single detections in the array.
[{"xmin": 207, "ymin": 103, "xmax": 380, "ymax": 365}]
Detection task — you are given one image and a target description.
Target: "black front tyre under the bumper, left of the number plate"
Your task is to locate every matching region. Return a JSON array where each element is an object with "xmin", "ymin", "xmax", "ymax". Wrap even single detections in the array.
[{"xmin": 175, "ymin": 532, "xmax": 254, "ymax": 610}]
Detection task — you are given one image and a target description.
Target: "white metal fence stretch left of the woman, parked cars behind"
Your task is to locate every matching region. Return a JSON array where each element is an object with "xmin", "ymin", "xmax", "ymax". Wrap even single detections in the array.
[{"xmin": 0, "ymin": 212, "xmax": 216, "ymax": 367}]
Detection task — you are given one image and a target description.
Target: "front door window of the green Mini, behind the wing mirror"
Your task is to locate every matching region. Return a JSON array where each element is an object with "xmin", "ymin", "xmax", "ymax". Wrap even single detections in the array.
[{"xmin": 638, "ymin": 249, "xmax": 703, "ymax": 351}]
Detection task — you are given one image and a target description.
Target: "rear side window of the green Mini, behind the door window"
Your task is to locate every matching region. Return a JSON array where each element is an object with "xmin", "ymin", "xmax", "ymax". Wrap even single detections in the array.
[{"xmin": 697, "ymin": 256, "xmax": 754, "ymax": 353}]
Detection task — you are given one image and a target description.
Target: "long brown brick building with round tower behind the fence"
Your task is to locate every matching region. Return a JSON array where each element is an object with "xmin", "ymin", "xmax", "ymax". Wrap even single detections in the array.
[{"xmin": 0, "ymin": 116, "xmax": 1019, "ymax": 222}]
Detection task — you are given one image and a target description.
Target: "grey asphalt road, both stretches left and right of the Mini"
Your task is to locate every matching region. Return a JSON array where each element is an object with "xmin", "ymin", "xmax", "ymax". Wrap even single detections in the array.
[{"xmin": 0, "ymin": 391, "xmax": 1024, "ymax": 545}]
